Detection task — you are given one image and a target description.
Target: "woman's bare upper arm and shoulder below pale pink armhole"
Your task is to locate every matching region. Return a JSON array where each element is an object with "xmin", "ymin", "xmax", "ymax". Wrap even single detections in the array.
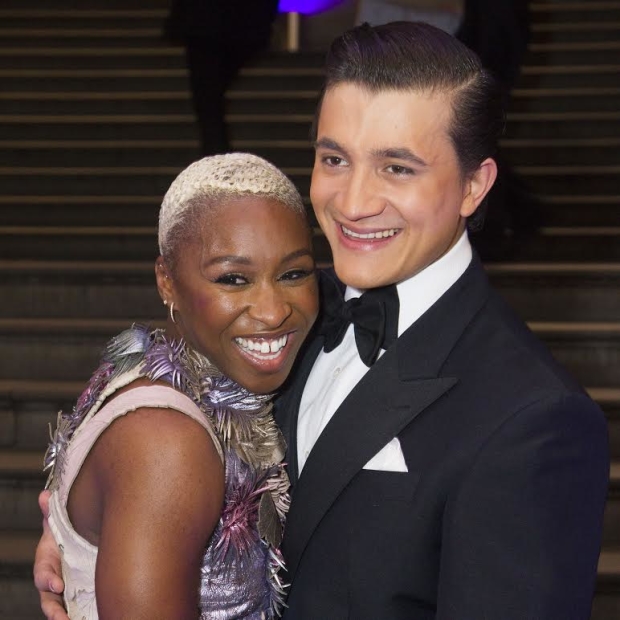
[{"xmin": 85, "ymin": 409, "xmax": 224, "ymax": 620}]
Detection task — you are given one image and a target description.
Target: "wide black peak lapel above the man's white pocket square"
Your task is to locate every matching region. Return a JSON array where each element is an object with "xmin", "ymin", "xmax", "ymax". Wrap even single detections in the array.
[{"xmin": 283, "ymin": 257, "xmax": 489, "ymax": 576}]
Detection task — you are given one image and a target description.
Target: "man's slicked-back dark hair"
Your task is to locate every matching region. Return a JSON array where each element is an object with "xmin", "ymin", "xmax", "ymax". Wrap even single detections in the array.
[{"xmin": 312, "ymin": 22, "xmax": 505, "ymax": 229}]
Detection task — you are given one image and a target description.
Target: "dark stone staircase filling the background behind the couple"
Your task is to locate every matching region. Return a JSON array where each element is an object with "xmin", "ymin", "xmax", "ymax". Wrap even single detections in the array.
[{"xmin": 0, "ymin": 0, "xmax": 620, "ymax": 620}]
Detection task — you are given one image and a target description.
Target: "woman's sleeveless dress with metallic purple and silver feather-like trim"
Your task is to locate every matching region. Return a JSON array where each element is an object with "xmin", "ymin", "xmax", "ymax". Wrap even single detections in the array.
[{"xmin": 45, "ymin": 326, "xmax": 289, "ymax": 620}]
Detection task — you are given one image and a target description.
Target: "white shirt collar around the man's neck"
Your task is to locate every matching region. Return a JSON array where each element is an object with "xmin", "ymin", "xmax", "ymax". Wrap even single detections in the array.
[{"xmin": 344, "ymin": 231, "xmax": 473, "ymax": 336}]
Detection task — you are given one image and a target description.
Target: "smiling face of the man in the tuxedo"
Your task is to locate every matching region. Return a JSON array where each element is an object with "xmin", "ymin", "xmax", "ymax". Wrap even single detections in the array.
[{"xmin": 310, "ymin": 83, "xmax": 494, "ymax": 289}]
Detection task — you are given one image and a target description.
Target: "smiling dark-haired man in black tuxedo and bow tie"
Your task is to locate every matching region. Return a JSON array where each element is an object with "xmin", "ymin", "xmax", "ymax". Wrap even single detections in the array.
[{"xmin": 35, "ymin": 23, "xmax": 609, "ymax": 620}]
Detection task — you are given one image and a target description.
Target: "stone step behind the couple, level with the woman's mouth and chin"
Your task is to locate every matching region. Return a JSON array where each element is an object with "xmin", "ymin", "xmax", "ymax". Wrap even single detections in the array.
[{"xmin": 0, "ymin": 315, "xmax": 620, "ymax": 387}]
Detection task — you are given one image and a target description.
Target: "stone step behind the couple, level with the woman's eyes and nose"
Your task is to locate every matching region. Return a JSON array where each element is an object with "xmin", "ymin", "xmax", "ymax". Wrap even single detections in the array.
[{"xmin": 0, "ymin": 259, "xmax": 620, "ymax": 323}]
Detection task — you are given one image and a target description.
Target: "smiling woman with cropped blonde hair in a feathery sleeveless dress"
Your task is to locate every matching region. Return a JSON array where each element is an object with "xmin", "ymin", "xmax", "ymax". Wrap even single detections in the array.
[{"xmin": 39, "ymin": 153, "xmax": 318, "ymax": 620}]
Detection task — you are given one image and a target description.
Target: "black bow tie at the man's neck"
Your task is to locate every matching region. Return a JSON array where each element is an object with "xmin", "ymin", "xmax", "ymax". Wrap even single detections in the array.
[{"xmin": 319, "ymin": 276, "xmax": 399, "ymax": 366}]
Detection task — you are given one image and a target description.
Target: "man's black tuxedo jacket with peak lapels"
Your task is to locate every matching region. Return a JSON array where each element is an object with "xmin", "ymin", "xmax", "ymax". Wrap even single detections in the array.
[{"xmin": 276, "ymin": 259, "xmax": 609, "ymax": 620}]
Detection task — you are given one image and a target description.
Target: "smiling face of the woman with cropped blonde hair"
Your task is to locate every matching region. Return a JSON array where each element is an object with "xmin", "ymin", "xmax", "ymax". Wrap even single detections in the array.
[{"xmin": 156, "ymin": 197, "xmax": 318, "ymax": 393}]
